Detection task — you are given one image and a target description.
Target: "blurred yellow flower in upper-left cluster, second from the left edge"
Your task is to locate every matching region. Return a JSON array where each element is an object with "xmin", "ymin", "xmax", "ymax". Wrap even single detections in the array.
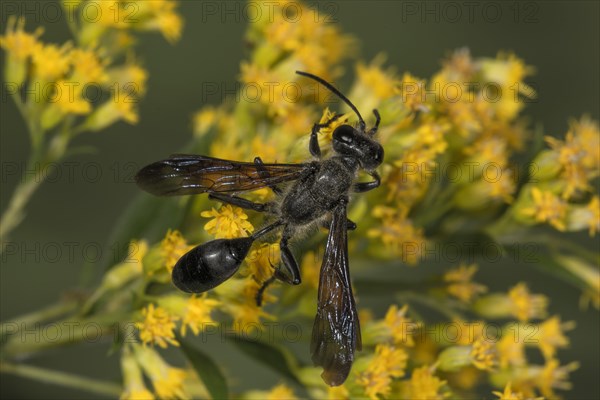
[{"xmin": 32, "ymin": 43, "xmax": 71, "ymax": 81}]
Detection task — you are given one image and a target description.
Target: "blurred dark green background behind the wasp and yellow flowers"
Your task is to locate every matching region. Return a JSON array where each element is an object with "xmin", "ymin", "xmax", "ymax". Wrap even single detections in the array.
[{"xmin": 0, "ymin": 0, "xmax": 600, "ymax": 399}]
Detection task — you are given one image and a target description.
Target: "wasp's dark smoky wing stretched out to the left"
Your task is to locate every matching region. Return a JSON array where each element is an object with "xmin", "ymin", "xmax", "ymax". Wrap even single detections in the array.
[{"xmin": 135, "ymin": 154, "xmax": 307, "ymax": 196}]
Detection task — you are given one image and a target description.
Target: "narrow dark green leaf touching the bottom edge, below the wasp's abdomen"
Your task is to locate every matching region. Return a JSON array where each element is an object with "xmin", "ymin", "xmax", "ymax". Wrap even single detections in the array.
[{"xmin": 178, "ymin": 338, "xmax": 229, "ymax": 400}]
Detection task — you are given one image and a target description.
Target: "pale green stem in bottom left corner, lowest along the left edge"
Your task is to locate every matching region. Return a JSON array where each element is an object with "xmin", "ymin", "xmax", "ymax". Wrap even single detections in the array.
[{"xmin": 0, "ymin": 362, "xmax": 122, "ymax": 397}]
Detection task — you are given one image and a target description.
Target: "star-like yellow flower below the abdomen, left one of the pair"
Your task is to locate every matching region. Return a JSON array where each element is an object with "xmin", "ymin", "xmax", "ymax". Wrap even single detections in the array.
[{"xmin": 136, "ymin": 304, "xmax": 179, "ymax": 348}]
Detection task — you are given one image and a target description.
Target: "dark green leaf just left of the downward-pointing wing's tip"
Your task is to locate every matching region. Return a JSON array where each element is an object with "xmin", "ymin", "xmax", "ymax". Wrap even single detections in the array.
[{"xmin": 230, "ymin": 335, "xmax": 302, "ymax": 385}]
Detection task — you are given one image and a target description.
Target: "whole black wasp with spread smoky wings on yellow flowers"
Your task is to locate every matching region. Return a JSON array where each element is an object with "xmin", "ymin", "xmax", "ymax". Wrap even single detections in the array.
[{"xmin": 136, "ymin": 71, "xmax": 383, "ymax": 386}]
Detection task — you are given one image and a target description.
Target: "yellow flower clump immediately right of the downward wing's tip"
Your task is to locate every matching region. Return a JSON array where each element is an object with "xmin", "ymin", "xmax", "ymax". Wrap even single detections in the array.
[{"xmin": 356, "ymin": 344, "xmax": 408, "ymax": 400}]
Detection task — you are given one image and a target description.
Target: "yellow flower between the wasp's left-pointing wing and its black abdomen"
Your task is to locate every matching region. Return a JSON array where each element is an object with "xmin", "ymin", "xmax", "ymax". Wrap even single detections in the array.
[{"xmin": 200, "ymin": 204, "xmax": 254, "ymax": 239}]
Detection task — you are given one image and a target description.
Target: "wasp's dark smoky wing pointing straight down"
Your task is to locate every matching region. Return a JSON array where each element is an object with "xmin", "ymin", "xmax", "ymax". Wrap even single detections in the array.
[{"xmin": 310, "ymin": 204, "xmax": 361, "ymax": 386}]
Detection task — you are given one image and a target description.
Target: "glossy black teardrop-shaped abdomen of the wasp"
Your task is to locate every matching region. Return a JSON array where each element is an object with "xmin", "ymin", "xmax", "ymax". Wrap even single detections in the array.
[{"xmin": 172, "ymin": 237, "xmax": 254, "ymax": 293}]
